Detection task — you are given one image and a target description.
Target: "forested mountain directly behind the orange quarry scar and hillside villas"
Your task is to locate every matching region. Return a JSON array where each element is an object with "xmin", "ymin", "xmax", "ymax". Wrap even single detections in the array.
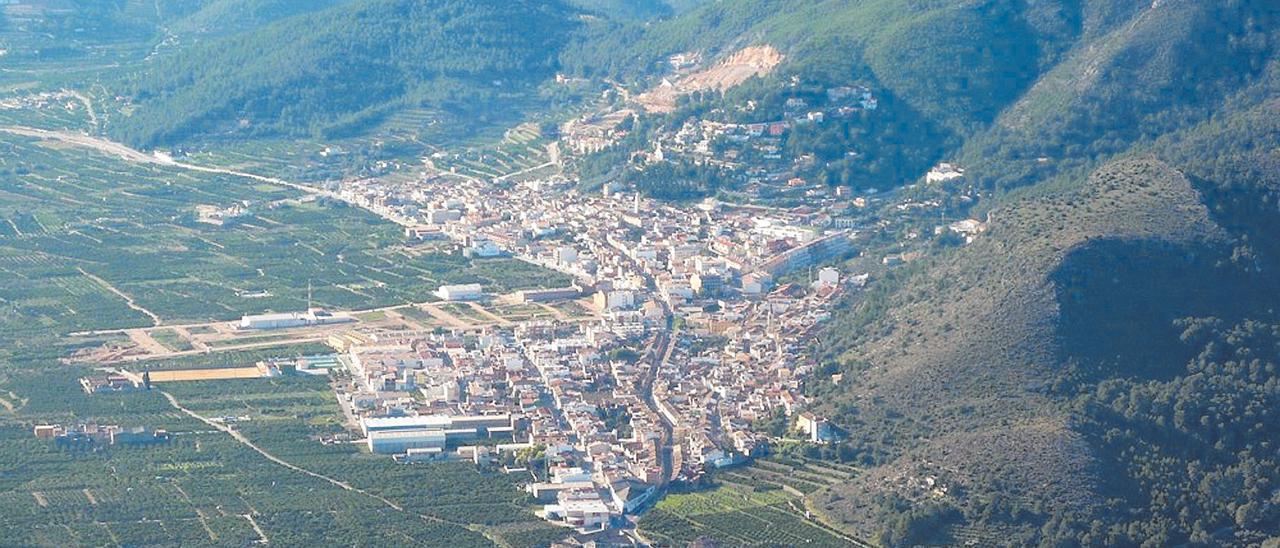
[{"xmin": 561, "ymin": 0, "xmax": 1080, "ymax": 197}]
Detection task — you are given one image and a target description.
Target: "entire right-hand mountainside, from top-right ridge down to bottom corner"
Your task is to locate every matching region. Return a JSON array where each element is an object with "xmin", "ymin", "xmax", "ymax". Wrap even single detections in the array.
[{"xmin": 798, "ymin": 9, "xmax": 1280, "ymax": 545}]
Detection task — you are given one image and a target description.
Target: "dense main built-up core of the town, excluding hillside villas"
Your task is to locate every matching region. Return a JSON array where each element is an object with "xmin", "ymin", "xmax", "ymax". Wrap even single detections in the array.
[{"xmin": 212, "ymin": 154, "xmax": 967, "ymax": 531}]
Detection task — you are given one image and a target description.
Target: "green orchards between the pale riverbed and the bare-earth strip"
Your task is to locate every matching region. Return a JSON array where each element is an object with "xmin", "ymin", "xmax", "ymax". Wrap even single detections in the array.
[{"xmin": 0, "ymin": 134, "xmax": 564, "ymax": 355}]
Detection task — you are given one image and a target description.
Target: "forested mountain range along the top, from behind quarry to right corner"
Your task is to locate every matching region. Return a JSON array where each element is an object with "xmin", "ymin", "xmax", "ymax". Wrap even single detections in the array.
[{"xmin": 562, "ymin": 0, "xmax": 1280, "ymax": 185}]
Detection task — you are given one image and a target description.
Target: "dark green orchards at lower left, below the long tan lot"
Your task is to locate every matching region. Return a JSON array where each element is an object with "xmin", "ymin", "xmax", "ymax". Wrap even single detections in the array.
[{"xmin": 0, "ymin": 375, "xmax": 563, "ymax": 547}]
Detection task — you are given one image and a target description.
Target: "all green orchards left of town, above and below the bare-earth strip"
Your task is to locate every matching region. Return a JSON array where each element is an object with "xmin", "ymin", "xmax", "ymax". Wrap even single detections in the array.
[{"xmin": 0, "ymin": 122, "xmax": 567, "ymax": 547}]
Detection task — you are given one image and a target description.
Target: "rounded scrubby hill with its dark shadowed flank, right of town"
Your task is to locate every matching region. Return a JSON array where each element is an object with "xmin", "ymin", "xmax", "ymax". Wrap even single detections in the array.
[{"xmin": 820, "ymin": 148, "xmax": 1277, "ymax": 544}]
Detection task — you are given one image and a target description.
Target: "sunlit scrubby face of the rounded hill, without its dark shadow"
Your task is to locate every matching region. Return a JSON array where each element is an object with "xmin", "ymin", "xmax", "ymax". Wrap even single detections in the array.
[{"xmin": 803, "ymin": 157, "xmax": 1229, "ymax": 542}]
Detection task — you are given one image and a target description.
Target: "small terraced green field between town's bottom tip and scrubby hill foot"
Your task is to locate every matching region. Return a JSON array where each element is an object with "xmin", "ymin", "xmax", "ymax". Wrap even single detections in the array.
[{"xmin": 639, "ymin": 461, "xmax": 855, "ymax": 547}]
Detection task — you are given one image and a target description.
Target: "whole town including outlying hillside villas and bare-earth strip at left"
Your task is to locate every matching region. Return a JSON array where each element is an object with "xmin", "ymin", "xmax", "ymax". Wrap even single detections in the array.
[{"xmin": 37, "ymin": 67, "xmax": 987, "ymax": 533}]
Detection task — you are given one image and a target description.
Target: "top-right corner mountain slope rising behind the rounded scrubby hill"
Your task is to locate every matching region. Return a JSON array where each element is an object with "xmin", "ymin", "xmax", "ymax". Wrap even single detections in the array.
[{"xmin": 960, "ymin": 0, "xmax": 1280, "ymax": 194}]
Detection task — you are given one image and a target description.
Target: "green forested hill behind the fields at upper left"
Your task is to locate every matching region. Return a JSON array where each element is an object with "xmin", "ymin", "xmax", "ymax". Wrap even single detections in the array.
[{"xmin": 113, "ymin": 0, "xmax": 575, "ymax": 147}]
